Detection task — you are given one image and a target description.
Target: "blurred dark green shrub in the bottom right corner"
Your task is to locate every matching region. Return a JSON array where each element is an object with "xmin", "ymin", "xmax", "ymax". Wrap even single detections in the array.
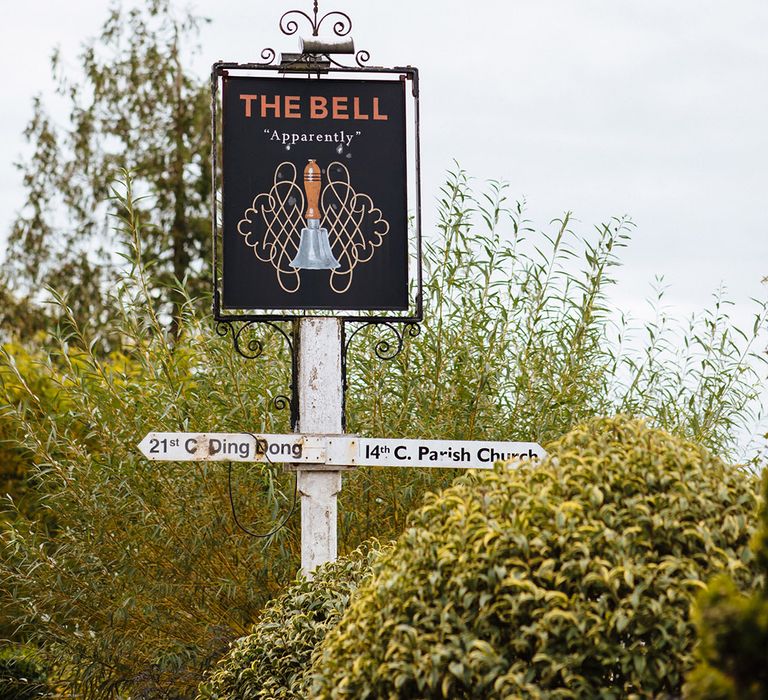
[{"xmin": 685, "ymin": 470, "xmax": 768, "ymax": 700}]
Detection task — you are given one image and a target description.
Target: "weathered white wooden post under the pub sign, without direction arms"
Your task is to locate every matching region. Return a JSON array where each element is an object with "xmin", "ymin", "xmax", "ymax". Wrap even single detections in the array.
[{"xmin": 297, "ymin": 318, "xmax": 343, "ymax": 576}]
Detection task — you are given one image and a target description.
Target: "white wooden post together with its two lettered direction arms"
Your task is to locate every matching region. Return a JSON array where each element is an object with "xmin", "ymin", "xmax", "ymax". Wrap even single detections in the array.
[{"xmin": 139, "ymin": 424, "xmax": 546, "ymax": 576}]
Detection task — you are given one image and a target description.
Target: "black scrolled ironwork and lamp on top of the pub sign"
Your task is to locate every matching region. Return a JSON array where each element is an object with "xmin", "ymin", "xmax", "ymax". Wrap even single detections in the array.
[{"xmin": 260, "ymin": 0, "xmax": 371, "ymax": 73}]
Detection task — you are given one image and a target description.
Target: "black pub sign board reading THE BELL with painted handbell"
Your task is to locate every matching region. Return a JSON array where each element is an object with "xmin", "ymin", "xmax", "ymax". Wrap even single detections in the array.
[{"xmin": 215, "ymin": 69, "xmax": 420, "ymax": 318}]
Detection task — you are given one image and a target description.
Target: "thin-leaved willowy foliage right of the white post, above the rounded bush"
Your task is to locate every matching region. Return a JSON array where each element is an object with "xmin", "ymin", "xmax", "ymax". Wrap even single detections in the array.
[{"xmin": 341, "ymin": 171, "xmax": 768, "ymax": 543}]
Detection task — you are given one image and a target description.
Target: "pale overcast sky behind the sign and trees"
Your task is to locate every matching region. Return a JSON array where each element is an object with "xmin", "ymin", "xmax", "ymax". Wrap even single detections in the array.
[{"xmin": 0, "ymin": 0, "xmax": 768, "ymax": 442}]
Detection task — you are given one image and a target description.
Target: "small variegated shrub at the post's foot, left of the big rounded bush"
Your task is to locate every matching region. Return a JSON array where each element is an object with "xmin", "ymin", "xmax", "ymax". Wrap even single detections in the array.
[{"xmin": 200, "ymin": 540, "xmax": 388, "ymax": 700}]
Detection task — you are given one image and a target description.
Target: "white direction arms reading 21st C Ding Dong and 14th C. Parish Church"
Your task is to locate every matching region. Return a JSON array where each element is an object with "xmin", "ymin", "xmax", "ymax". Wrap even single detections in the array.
[{"xmin": 139, "ymin": 433, "xmax": 547, "ymax": 469}]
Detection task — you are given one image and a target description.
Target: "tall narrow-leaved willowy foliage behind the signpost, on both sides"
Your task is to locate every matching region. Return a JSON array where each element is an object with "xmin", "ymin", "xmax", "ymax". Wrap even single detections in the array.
[{"xmin": 0, "ymin": 172, "xmax": 765, "ymax": 698}]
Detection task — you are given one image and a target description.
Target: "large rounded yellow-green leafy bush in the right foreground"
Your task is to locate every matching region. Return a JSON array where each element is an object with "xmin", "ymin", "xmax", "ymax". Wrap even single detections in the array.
[{"xmin": 313, "ymin": 418, "xmax": 757, "ymax": 700}]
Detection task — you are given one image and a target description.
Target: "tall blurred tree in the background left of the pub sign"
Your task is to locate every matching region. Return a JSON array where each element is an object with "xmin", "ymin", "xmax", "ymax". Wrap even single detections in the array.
[{"xmin": 6, "ymin": 0, "xmax": 211, "ymax": 336}]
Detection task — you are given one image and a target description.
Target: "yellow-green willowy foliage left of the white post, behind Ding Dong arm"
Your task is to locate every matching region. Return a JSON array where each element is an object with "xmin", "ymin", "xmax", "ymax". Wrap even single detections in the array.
[{"xmin": 0, "ymin": 183, "xmax": 300, "ymax": 698}]
